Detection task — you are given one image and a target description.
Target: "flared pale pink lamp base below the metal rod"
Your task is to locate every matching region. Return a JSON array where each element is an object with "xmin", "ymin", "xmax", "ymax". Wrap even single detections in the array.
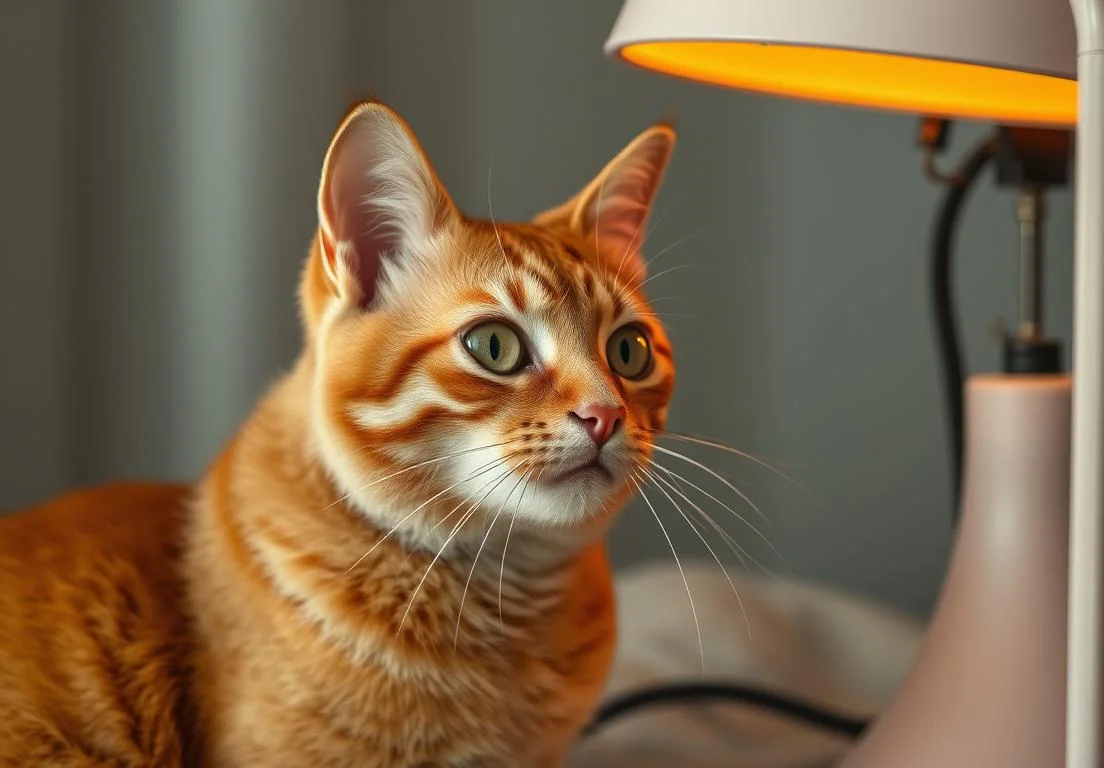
[{"xmin": 841, "ymin": 374, "xmax": 1071, "ymax": 768}]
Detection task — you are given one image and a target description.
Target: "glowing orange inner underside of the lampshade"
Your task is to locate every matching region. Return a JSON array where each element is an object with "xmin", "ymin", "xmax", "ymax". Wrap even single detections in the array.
[{"xmin": 620, "ymin": 41, "xmax": 1078, "ymax": 125}]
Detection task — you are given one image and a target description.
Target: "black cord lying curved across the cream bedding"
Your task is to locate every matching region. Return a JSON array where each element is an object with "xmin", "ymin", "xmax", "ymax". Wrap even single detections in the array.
[{"xmin": 583, "ymin": 683, "xmax": 868, "ymax": 738}]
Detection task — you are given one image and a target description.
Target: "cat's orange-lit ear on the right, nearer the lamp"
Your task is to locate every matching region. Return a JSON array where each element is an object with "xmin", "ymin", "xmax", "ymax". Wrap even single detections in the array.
[{"xmin": 533, "ymin": 122, "xmax": 676, "ymax": 280}]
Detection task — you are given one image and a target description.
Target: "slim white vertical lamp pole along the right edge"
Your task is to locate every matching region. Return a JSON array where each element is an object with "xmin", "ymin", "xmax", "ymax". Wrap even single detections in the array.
[{"xmin": 1065, "ymin": 0, "xmax": 1104, "ymax": 768}]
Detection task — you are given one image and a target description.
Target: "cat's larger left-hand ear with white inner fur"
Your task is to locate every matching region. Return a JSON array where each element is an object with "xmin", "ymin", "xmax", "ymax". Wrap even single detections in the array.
[{"xmin": 318, "ymin": 103, "xmax": 456, "ymax": 308}]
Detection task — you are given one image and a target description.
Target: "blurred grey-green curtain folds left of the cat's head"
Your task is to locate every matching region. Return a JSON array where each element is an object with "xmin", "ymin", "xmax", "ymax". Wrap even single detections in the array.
[{"xmin": 0, "ymin": 0, "xmax": 352, "ymax": 508}]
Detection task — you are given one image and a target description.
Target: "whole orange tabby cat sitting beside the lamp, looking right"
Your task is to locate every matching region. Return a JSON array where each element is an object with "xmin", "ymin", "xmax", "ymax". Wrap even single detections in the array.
[{"xmin": 0, "ymin": 103, "xmax": 675, "ymax": 768}]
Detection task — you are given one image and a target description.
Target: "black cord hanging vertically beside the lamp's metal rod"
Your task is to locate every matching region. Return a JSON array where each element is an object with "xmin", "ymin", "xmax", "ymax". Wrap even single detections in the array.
[{"xmin": 931, "ymin": 137, "xmax": 997, "ymax": 523}]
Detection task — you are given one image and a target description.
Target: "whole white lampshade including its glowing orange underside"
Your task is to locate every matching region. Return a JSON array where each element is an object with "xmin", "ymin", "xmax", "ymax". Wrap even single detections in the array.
[{"xmin": 605, "ymin": 0, "xmax": 1078, "ymax": 125}]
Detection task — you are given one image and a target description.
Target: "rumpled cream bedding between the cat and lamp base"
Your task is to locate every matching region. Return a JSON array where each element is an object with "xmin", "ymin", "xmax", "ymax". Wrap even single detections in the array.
[{"xmin": 566, "ymin": 562, "xmax": 923, "ymax": 768}]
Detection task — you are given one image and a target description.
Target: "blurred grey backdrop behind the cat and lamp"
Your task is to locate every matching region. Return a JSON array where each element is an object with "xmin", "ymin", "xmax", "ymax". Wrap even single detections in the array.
[{"xmin": 0, "ymin": 0, "xmax": 1071, "ymax": 612}]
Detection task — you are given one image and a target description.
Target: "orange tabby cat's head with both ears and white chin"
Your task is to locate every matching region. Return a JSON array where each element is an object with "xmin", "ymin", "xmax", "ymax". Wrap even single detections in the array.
[{"xmin": 301, "ymin": 103, "xmax": 675, "ymax": 545}]
